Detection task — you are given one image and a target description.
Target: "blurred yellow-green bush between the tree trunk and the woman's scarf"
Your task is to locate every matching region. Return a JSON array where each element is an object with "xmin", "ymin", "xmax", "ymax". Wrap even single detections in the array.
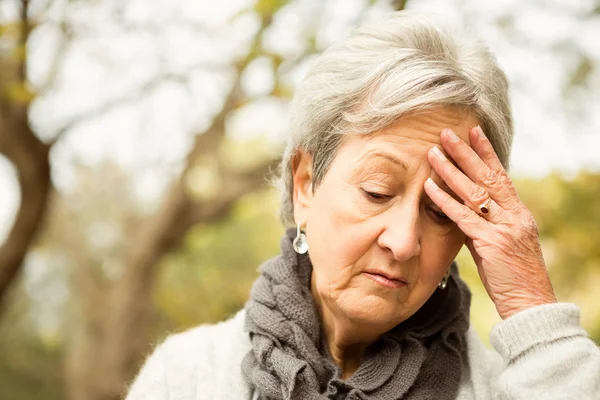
[{"xmin": 154, "ymin": 192, "xmax": 283, "ymax": 335}]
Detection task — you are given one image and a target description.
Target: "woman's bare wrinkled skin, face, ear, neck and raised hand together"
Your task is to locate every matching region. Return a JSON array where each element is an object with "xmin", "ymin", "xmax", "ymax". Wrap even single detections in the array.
[{"xmin": 293, "ymin": 109, "xmax": 555, "ymax": 376}]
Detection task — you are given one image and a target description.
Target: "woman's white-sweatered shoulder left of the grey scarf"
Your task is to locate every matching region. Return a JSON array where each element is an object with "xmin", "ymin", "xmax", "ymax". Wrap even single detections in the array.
[{"xmin": 127, "ymin": 310, "xmax": 251, "ymax": 400}]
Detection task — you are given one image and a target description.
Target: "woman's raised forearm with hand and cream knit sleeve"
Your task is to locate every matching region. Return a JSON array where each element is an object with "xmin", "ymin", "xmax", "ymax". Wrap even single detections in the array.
[{"xmin": 425, "ymin": 127, "xmax": 600, "ymax": 400}]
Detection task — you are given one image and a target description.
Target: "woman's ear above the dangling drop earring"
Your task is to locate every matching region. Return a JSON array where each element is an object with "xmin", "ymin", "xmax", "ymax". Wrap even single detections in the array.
[{"xmin": 292, "ymin": 150, "xmax": 313, "ymax": 225}]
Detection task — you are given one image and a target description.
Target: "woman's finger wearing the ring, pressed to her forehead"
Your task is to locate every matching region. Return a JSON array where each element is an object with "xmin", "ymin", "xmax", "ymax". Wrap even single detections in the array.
[{"xmin": 428, "ymin": 146, "xmax": 504, "ymax": 223}]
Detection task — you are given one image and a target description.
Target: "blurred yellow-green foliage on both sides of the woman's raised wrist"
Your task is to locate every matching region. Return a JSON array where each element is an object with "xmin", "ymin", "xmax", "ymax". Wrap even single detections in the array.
[{"xmin": 458, "ymin": 172, "xmax": 600, "ymax": 343}]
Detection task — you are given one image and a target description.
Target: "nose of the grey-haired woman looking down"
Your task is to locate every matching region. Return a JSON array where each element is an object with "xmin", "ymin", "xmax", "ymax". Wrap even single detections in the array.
[{"xmin": 377, "ymin": 202, "xmax": 421, "ymax": 262}]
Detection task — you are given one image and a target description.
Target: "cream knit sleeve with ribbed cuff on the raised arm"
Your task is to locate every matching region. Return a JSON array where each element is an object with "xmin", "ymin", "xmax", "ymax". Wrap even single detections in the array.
[{"xmin": 490, "ymin": 303, "xmax": 600, "ymax": 400}]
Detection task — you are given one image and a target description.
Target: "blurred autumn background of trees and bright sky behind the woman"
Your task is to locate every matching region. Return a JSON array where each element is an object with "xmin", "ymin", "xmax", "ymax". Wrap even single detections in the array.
[{"xmin": 0, "ymin": 0, "xmax": 600, "ymax": 400}]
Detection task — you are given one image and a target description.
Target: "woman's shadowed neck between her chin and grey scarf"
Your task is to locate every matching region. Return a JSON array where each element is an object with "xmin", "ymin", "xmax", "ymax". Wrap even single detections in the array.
[{"xmin": 311, "ymin": 273, "xmax": 381, "ymax": 379}]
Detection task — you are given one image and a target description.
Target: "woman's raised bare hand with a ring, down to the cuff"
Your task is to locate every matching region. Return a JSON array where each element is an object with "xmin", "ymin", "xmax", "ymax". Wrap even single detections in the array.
[{"xmin": 425, "ymin": 127, "xmax": 556, "ymax": 319}]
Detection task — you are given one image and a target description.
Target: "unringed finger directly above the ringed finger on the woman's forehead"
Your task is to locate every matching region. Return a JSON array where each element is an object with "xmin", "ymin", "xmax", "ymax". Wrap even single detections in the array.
[{"xmin": 441, "ymin": 129, "xmax": 515, "ymax": 209}]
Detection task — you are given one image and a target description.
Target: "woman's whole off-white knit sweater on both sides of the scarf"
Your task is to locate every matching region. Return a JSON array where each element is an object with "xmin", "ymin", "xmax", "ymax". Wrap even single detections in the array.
[{"xmin": 127, "ymin": 303, "xmax": 600, "ymax": 400}]
